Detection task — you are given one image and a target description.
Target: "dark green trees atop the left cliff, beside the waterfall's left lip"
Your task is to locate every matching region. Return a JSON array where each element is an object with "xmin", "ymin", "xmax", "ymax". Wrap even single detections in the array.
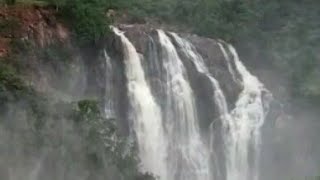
[{"xmin": 0, "ymin": 0, "xmax": 112, "ymax": 45}]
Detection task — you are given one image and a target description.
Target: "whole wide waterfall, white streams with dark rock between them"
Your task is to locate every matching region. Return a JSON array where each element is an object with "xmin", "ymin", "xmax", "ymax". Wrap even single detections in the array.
[{"xmin": 105, "ymin": 25, "xmax": 270, "ymax": 180}]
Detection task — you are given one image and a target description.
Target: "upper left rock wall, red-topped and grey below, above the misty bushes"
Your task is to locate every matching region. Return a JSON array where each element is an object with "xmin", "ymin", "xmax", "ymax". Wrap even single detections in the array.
[{"xmin": 0, "ymin": 6, "xmax": 104, "ymax": 100}]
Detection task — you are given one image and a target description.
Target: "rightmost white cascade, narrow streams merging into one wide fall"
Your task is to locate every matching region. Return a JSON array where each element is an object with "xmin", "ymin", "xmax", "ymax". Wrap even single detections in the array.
[{"xmin": 172, "ymin": 33, "xmax": 272, "ymax": 180}]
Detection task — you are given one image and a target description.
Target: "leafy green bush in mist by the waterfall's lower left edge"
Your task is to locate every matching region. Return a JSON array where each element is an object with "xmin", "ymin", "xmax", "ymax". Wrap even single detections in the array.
[{"xmin": 72, "ymin": 100, "xmax": 153, "ymax": 180}]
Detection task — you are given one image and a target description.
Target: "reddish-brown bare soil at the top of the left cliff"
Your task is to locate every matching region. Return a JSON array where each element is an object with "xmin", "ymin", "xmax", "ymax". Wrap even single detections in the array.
[{"xmin": 0, "ymin": 5, "xmax": 69, "ymax": 57}]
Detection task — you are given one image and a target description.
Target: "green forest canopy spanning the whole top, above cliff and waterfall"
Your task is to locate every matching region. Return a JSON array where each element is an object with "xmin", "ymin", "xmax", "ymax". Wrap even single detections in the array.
[{"xmin": 2, "ymin": 0, "xmax": 320, "ymax": 101}]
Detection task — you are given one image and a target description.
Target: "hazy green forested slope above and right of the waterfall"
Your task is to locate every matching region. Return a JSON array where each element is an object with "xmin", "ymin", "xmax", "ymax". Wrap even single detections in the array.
[{"xmin": 114, "ymin": 0, "xmax": 320, "ymax": 103}]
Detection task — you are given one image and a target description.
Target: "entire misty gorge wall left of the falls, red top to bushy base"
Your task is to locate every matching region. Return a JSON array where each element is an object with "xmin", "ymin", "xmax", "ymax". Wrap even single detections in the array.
[{"xmin": 0, "ymin": 6, "xmax": 120, "ymax": 180}]
